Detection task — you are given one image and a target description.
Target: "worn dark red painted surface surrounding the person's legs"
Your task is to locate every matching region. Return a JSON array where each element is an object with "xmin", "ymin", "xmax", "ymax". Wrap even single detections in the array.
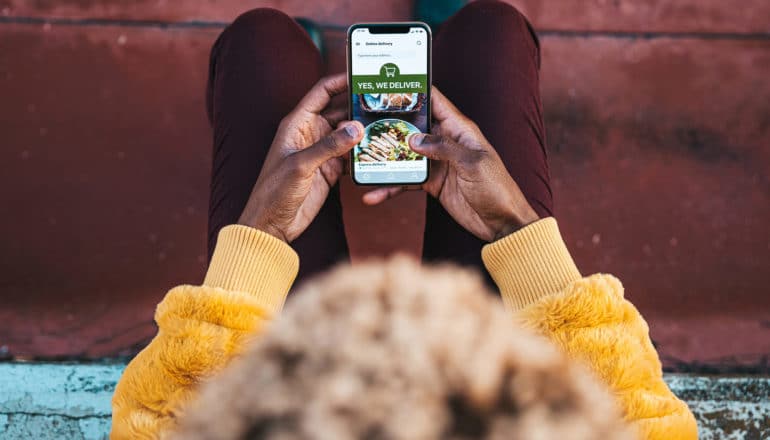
[{"xmin": 0, "ymin": 0, "xmax": 770, "ymax": 368}]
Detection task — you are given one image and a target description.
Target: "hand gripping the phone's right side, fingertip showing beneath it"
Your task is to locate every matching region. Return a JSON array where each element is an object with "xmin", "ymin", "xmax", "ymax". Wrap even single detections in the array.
[{"xmin": 363, "ymin": 87, "xmax": 538, "ymax": 241}]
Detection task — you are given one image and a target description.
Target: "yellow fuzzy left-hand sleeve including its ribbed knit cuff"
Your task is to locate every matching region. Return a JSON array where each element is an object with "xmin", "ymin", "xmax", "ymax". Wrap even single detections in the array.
[{"xmin": 110, "ymin": 225, "xmax": 299, "ymax": 439}]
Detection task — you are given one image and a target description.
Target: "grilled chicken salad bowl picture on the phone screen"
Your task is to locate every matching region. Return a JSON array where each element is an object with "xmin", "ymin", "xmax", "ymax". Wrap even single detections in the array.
[{"xmin": 355, "ymin": 119, "xmax": 424, "ymax": 162}]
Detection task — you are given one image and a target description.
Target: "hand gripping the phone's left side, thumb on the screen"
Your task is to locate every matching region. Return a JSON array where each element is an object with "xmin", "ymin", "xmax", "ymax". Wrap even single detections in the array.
[{"xmin": 238, "ymin": 74, "xmax": 364, "ymax": 243}]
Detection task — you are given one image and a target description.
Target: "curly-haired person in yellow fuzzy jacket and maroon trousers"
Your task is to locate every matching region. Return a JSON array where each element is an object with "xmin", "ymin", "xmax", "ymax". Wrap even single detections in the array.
[{"xmin": 111, "ymin": 1, "xmax": 697, "ymax": 439}]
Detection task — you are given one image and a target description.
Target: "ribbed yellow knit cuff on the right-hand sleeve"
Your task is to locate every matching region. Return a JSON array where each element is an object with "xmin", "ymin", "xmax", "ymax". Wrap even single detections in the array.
[{"xmin": 481, "ymin": 217, "xmax": 580, "ymax": 311}]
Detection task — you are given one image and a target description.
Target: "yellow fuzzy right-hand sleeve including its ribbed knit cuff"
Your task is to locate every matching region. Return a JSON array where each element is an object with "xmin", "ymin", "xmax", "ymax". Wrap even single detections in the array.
[{"xmin": 483, "ymin": 218, "xmax": 698, "ymax": 440}]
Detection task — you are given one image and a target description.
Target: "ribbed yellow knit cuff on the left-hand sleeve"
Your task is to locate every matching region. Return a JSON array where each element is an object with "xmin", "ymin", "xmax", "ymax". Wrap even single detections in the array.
[{"xmin": 203, "ymin": 225, "xmax": 299, "ymax": 313}]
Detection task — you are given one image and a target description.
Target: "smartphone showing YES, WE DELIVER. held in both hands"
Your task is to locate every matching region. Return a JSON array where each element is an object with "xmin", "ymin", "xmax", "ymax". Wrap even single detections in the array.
[{"xmin": 347, "ymin": 22, "xmax": 431, "ymax": 185}]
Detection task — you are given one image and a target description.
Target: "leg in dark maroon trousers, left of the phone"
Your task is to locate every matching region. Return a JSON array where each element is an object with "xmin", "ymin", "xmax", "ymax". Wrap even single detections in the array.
[{"xmin": 206, "ymin": 9, "xmax": 347, "ymax": 278}]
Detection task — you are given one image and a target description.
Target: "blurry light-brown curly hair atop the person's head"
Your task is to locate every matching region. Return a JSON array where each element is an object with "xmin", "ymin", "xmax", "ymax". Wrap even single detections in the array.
[{"xmin": 171, "ymin": 257, "xmax": 629, "ymax": 440}]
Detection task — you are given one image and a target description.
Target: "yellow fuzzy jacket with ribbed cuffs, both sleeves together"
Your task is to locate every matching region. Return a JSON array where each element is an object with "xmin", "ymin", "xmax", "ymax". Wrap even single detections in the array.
[{"xmin": 111, "ymin": 218, "xmax": 698, "ymax": 440}]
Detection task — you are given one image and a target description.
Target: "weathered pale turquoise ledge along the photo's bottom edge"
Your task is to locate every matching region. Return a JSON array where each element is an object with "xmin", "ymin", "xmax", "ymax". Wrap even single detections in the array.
[{"xmin": 0, "ymin": 363, "xmax": 770, "ymax": 440}]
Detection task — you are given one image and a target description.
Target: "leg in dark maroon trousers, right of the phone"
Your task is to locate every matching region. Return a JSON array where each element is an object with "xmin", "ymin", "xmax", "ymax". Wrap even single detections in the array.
[{"xmin": 424, "ymin": 0, "xmax": 553, "ymax": 276}]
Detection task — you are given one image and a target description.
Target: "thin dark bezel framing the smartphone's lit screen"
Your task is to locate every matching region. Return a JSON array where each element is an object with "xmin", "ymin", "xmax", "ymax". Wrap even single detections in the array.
[{"xmin": 345, "ymin": 21, "xmax": 433, "ymax": 186}]
